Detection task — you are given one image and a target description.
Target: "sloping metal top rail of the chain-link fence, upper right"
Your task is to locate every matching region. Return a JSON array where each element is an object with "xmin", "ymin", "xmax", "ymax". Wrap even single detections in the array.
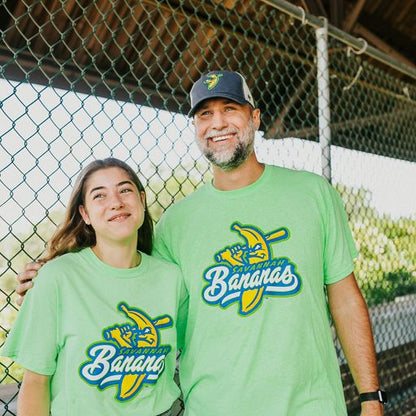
[{"xmin": 262, "ymin": 0, "xmax": 416, "ymax": 80}]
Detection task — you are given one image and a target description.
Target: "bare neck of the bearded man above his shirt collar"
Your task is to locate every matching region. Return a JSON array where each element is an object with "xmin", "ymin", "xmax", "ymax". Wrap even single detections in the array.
[{"xmin": 213, "ymin": 152, "xmax": 264, "ymax": 191}]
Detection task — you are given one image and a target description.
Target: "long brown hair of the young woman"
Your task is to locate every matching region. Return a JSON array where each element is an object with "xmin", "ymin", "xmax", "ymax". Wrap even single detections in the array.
[{"xmin": 40, "ymin": 157, "xmax": 153, "ymax": 261}]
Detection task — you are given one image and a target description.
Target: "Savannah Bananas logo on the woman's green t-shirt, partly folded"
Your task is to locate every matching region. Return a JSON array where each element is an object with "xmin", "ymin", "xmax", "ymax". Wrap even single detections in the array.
[{"xmin": 80, "ymin": 302, "xmax": 173, "ymax": 401}]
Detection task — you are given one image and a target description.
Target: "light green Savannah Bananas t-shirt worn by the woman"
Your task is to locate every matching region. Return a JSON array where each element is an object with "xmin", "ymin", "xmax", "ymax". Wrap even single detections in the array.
[{"xmin": 1, "ymin": 248, "xmax": 185, "ymax": 416}]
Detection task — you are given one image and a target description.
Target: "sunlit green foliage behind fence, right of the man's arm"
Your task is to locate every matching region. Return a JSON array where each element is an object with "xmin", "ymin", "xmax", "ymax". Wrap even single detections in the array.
[{"xmin": 336, "ymin": 185, "xmax": 416, "ymax": 306}]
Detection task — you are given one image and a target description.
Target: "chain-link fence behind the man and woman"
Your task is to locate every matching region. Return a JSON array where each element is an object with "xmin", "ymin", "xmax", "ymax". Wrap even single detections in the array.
[{"xmin": 0, "ymin": 0, "xmax": 416, "ymax": 416}]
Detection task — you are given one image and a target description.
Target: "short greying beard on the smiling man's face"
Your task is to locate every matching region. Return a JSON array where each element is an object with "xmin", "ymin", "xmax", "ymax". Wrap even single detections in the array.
[{"xmin": 197, "ymin": 120, "xmax": 256, "ymax": 172}]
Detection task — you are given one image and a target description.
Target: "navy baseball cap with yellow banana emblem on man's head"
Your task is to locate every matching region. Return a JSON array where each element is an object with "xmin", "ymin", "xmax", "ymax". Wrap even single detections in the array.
[{"xmin": 188, "ymin": 71, "xmax": 254, "ymax": 117}]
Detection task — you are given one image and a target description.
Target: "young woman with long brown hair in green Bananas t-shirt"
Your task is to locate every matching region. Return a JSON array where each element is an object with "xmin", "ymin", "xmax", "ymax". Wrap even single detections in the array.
[{"xmin": 1, "ymin": 158, "xmax": 186, "ymax": 416}]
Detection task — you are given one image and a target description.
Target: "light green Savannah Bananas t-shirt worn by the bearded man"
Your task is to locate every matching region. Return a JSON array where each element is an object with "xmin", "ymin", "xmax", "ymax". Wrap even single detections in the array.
[{"xmin": 155, "ymin": 166, "xmax": 357, "ymax": 416}]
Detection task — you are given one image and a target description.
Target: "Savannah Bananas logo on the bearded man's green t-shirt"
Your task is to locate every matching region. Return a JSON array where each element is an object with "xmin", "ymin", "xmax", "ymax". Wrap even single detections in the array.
[{"xmin": 203, "ymin": 222, "xmax": 301, "ymax": 316}]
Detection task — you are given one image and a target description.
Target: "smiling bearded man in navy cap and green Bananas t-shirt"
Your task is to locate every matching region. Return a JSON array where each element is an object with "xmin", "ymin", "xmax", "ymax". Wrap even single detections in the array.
[{"xmin": 17, "ymin": 71, "xmax": 383, "ymax": 416}]
